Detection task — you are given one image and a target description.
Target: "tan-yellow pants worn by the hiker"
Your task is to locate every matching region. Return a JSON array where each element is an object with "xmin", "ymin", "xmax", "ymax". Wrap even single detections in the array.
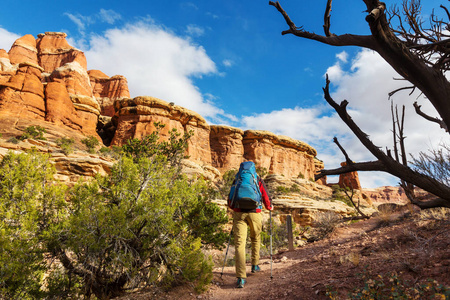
[{"xmin": 233, "ymin": 212, "xmax": 262, "ymax": 278}]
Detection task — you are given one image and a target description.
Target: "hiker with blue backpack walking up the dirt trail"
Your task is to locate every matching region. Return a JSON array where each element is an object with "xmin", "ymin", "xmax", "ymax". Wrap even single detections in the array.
[{"xmin": 228, "ymin": 161, "xmax": 273, "ymax": 288}]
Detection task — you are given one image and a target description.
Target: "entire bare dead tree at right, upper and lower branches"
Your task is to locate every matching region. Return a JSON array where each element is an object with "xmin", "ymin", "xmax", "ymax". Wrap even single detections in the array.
[{"xmin": 269, "ymin": 0, "xmax": 450, "ymax": 208}]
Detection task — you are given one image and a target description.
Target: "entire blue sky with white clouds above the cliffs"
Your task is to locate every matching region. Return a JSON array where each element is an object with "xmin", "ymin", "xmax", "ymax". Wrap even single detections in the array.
[{"xmin": 0, "ymin": 0, "xmax": 448, "ymax": 187}]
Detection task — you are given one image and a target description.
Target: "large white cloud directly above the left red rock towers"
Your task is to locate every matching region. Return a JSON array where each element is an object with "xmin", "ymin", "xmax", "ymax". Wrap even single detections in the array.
[{"xmin": 85, "ymin": 22, "xmax": 232, "ymax": 119}]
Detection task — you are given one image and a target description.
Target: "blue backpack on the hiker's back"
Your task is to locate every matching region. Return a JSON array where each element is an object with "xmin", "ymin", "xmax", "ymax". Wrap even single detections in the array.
[{"xmin": 228, "ymin": 161, "xmax": 261, "ymax": 209}]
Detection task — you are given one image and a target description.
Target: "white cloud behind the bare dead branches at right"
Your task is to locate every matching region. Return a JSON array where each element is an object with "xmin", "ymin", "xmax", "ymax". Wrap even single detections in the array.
[{"xmin": 237, "ymin": 50, "xmax": 450, "ymax": 187}]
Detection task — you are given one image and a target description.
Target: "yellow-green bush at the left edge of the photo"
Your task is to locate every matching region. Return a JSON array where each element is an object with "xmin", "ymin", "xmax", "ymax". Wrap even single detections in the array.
[{"xmin": 0, "ymin": 152, "xmax": 66, "ymax": 299}]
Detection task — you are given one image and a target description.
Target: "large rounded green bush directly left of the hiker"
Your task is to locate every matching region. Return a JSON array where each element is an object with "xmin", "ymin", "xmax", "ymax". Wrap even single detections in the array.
[{"xmin": 52, "ymin": 155, "xmax": 227, "ymax": 298}]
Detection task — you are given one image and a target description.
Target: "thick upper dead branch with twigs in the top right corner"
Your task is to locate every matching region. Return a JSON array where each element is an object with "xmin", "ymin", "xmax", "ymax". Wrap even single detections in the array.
[{"xmin": 269, "ymin": 0, "xmax": 450, "ymax": 129}]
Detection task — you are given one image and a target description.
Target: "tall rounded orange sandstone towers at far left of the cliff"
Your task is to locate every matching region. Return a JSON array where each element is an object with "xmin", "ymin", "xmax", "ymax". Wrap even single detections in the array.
[{"xmin": 0, "ymin": 32, "xmax": 129, "ymax": 138}]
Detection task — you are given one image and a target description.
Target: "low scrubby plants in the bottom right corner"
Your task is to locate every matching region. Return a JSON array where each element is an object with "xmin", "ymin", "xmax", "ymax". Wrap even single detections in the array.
[{"xmin": 342, "ymin": 272, "xmax": 450, "ymax": 299}]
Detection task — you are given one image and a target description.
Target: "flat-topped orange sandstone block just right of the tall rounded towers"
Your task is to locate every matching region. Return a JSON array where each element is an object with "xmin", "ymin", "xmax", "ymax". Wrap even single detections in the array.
[{"xmin": 112, "ymin": 97, "xmax": 211, "ymax": 164}]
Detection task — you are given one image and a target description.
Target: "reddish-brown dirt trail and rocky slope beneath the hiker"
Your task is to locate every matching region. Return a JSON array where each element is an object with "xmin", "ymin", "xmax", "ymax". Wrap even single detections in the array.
[{"xmin": 121, "ymin": 210, "xmax": 450, "ymax": 300}]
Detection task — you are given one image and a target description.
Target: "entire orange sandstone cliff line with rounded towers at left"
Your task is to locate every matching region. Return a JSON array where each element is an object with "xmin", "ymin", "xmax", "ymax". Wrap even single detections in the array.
[{"xmin": 0, "ymin": 32, "xmax": 323, "ymax": 179}]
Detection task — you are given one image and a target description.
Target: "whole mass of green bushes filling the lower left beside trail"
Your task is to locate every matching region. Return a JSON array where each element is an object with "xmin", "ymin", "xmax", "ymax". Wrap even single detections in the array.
[{"xmin": 0, "ymin": 124, "xmax": 228, "ymax": 299}]
